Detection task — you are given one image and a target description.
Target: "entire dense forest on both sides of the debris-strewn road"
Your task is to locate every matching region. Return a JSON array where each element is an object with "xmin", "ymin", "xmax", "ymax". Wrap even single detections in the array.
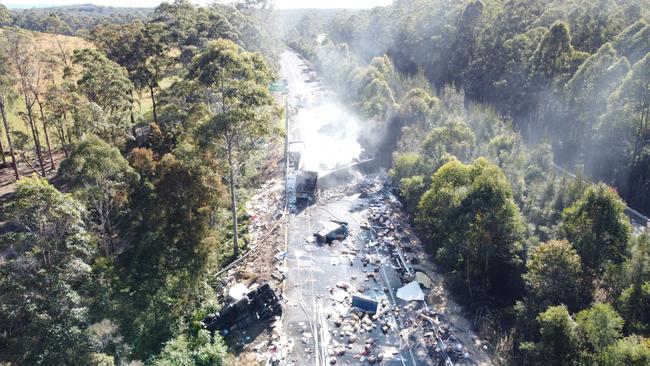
[{"xmin": 0, "ymin": 0, "xmax": 650, "ymax": 366}]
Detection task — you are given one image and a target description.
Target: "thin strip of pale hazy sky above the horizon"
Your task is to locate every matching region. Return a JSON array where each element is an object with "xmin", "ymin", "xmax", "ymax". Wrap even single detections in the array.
[{"xmin": 5, "ymin": 0, "xmax": 392, "ymax": 9}]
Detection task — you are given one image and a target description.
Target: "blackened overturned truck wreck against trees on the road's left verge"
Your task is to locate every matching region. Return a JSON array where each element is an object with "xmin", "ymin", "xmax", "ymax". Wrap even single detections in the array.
[{"xmin": 201, "ymin": 283, "xmax": 282, "ymax": 335}]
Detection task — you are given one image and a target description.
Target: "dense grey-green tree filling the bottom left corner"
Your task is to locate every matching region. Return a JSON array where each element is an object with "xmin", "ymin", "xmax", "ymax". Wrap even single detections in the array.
[{"xmin": 0, "ymin": 176, "xmax": 95, "ymax": 365}]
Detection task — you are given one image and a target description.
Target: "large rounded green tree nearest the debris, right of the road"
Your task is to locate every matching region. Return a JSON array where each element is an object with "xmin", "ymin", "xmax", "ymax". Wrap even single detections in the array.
[{"xmin": 416, "ymin": 158, "xmax": 523, "ymax": 301}]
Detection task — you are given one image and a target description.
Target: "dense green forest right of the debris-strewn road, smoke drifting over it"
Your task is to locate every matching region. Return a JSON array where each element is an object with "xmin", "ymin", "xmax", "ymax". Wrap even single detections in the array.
[{"xmin": 283, "ymin": 0, "xmax": 650, "ymax": 365}]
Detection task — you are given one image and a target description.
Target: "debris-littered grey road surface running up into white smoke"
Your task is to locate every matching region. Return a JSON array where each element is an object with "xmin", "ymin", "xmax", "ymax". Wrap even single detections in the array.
[{"xmin": 282, "ymin": 52, "xmax": 489, "ymax": 366}]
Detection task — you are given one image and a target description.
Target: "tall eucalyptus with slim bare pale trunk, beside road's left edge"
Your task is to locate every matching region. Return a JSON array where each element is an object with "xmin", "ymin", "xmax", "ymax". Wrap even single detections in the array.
[{"xmin": 188, "ymin": 39, "xmax": 278, "ymax": 257}]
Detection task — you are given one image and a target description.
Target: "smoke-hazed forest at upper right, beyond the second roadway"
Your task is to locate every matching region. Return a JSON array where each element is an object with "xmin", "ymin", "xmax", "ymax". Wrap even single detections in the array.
[{"xmin": 286, "ymin": 0, "xmax": 650, "ymax": 212}]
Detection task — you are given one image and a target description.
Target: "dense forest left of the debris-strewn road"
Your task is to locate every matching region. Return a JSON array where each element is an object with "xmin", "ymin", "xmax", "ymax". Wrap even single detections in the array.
[{"xmin": 0, "ymin": 0, "xmax": 281, "ymax": 365}]
